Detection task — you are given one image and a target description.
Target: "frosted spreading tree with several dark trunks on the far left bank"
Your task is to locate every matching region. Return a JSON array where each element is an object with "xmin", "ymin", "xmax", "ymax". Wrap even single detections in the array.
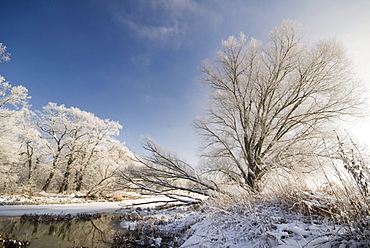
[{"xmin": 36, "ymin": 103, "xmax": 121, "ymax": 192}]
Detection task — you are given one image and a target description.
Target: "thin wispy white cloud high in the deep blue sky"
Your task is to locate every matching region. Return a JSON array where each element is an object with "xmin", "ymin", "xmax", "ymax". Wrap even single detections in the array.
[{"xmin": 115, "ymin": 0, "xmax": 222, "ymax": 49}]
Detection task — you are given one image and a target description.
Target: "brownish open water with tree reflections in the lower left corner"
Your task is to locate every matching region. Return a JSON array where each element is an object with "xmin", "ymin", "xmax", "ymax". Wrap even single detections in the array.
[{"xmin": 0, "ymin": 215, "xmax": 120, "ymax": 248}]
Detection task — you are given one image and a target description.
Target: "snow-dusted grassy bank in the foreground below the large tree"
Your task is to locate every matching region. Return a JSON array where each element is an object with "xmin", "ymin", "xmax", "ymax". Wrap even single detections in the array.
[{"xmin": 105, "ymin": 198, "xmax": 370, "ymax": 248}]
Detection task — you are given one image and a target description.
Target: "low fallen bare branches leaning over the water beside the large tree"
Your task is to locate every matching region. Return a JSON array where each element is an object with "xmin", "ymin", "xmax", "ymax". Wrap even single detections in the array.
[{"xmin": 119, "ymin": 138, "xmax": 220, "ymax": 203}]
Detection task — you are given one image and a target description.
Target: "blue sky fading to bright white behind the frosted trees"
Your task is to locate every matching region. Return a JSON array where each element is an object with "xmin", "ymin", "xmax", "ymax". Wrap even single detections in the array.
[{"xmin": 0, "ymin": 0, "xmax": 370, "ymax": 165}]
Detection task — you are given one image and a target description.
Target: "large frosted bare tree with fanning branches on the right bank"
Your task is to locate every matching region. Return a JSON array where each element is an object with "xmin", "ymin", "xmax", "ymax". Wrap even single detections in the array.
[{"xmin": 196, "ymin": 21, "xmax": 362, "ymax": 191}]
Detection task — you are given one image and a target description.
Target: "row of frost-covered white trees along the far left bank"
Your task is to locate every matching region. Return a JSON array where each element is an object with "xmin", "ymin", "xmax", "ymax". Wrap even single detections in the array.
[{"xmin": 0, "ymin": 48, "xmax": 131, "ymax": 194}]
